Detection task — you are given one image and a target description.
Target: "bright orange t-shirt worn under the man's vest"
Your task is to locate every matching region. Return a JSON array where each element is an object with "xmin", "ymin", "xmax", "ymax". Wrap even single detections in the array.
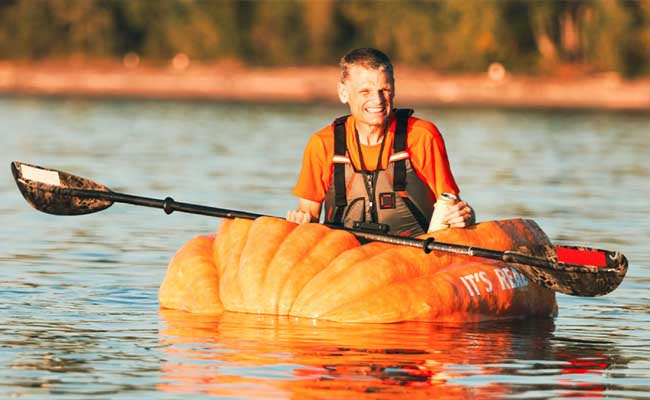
[{"xmin": 293, "ymin": 115, "xmax": 459, "ymax": 203}]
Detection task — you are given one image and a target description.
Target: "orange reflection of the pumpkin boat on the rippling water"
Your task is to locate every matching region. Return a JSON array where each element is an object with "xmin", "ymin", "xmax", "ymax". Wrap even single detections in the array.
[{"xmin": 154, "ymin": 310, "xmax": 607, "ymax": 399}]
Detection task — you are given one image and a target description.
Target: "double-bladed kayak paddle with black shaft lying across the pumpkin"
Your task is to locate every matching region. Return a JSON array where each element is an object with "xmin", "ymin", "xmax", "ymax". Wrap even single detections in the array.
[{"xmin": 11, "ymin": 161, "xmax": 628, "ymax": 297}]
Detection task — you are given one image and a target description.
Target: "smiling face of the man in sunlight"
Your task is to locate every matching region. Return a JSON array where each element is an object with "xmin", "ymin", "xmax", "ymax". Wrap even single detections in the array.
[{"xmin": 338, "ymin": 65, "xmax": 395, "ymax": 127}]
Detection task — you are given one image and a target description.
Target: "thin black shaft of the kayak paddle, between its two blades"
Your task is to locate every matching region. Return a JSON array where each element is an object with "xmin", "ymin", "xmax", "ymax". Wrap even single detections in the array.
[{"xmin": 60, "ymin": 188, "xmax": 554, "ymax": 268}]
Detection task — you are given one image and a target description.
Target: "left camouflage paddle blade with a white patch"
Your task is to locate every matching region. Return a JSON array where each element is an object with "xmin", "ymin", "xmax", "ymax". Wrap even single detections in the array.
[{"xmin": 11, "ymin": 161, "xmax": 113, "ymax": 215}]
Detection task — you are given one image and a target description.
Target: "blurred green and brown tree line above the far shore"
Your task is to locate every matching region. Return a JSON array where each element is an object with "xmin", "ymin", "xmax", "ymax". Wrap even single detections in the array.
[{"xmin": 0, "ymin": 0, "xmax": 650, "ymax": 77}]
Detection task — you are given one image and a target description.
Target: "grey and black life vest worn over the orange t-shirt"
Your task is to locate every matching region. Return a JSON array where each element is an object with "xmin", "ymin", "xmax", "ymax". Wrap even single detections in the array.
[{"xmin": 324, "ymin": 109, "xmax": 435, "ymax": 236}]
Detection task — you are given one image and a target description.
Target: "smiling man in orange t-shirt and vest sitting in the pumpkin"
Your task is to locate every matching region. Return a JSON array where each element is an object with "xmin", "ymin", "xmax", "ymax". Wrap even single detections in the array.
[{"xmin": 287, "ymin": 48, "xmax": 474, "ymax": 236}]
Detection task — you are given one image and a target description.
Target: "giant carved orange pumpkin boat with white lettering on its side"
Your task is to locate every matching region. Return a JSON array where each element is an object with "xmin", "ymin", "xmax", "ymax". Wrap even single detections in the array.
[{"xmin": 159, "ymin": 217, "xmax": 557, "ymax": 323}]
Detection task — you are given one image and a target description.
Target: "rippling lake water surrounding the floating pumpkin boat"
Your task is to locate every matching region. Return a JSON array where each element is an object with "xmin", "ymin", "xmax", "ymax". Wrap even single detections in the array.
[{"xmin": 0, "ymin": 98, "xmax": 650, "ymax": 399}]
